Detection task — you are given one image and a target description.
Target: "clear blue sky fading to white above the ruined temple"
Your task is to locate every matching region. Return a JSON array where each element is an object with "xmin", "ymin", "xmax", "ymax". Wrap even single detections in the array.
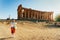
[{"xmin": 0, "ymin": 0, "xmax": 60, "ymax": 19}]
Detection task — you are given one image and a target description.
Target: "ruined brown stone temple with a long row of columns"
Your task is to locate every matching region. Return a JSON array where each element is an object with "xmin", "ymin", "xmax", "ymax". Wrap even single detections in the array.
[{"xmin": 17, "ymin": 5, "xmax": 53, "ymax": 21}]
